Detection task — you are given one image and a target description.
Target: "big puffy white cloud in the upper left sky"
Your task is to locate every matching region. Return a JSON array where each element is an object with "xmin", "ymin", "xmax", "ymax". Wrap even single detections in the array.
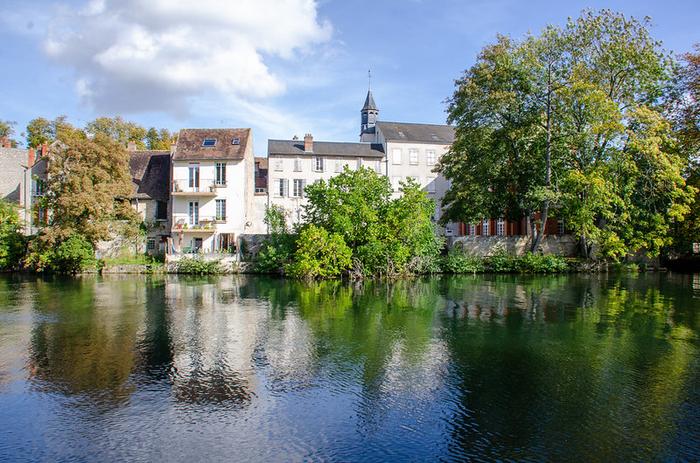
[{"xmin": 44, "ymin": 0, "xmax": 331, "ymax": 114}]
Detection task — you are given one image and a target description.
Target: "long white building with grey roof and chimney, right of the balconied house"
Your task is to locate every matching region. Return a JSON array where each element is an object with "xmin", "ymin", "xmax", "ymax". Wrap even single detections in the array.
[{"xmin": 267, "ymin": 134, "xmax": 386, "ymax": 224}]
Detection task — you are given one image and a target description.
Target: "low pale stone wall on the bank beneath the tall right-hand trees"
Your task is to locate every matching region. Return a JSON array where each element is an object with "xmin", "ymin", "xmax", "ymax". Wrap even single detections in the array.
[{"xmin": 450, "ymin": 235, "xmax": 578, "ymax": 257}]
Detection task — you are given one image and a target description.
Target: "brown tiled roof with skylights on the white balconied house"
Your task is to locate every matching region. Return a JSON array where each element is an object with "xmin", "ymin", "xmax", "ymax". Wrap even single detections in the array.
[{"xmin": 173, "ymin": 129, "xmax": 251, "ymax": 161}]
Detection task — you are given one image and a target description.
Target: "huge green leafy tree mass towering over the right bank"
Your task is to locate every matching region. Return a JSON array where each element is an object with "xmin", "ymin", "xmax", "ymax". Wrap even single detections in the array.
[{"xmin": 439, "ymin": 10, "xmax": 692, "ymax": 258}]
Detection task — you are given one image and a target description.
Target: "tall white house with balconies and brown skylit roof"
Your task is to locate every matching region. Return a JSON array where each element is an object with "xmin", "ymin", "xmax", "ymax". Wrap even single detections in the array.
[{"xmin": 169, "ymin": 129, "xmax": 255, "ymax": 253}]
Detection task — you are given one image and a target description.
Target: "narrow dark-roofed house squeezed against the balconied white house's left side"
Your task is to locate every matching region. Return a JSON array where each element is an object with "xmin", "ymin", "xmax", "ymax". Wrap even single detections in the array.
[{"xmin": 129, "ymin": 147, "xmax": 170, "ymax": 254}]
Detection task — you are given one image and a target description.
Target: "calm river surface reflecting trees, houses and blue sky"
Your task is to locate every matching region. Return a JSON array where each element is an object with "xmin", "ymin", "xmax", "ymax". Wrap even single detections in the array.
[{"xmin": 0, "ymin": 274, "xmax": 700, "ymax": 461}]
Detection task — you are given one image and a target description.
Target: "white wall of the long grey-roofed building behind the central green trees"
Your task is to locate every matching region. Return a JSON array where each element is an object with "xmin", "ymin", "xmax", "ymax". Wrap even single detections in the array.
[{"xmin": 263, "ymin": 153, "xmax": 386, "ymax": 224}]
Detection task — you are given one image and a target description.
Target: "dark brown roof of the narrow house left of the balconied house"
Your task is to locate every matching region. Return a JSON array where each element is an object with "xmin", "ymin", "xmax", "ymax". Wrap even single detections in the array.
[{"xmin": 129, "ymin": 151, "xmax": 170, "ymax": 201}]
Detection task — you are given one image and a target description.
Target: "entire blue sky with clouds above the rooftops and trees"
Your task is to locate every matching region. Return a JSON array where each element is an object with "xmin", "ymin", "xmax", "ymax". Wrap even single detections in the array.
[{"xmin": 0, "ymin": 0, "xmax": 700, "ymax": 155}]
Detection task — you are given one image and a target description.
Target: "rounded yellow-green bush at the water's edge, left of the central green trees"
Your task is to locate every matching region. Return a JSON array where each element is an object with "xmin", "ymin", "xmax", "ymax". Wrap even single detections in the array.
[{"xmin": 285, "ymin": 225, "xmax": 352, "ymax": 279}]
